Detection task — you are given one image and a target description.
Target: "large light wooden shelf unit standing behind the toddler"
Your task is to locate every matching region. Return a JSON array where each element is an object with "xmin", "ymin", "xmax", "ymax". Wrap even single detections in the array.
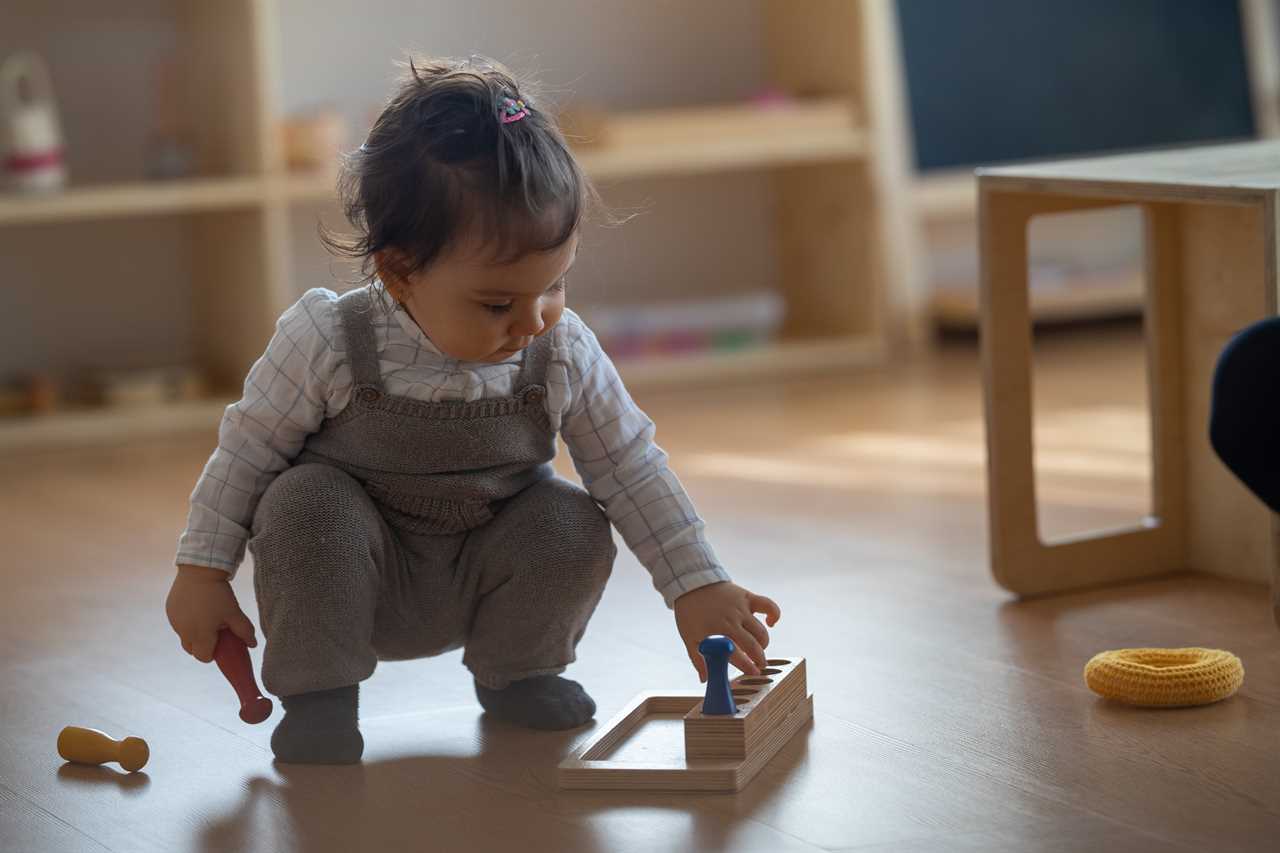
[{"xmin": 0, "ymin": 0, "xmax": 921, "ymax": 450}]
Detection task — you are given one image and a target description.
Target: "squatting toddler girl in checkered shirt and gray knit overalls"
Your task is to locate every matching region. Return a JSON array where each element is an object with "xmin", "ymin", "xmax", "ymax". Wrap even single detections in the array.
[{"xmin": 166, "ymin": 61, "xmax": 780, "ymax": 763}]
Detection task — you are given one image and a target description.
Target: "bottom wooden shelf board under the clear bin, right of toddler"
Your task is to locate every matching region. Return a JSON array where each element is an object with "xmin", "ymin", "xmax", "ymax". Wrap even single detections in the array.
[{"xmin": 617, "ymin": 336, "xmax": 884, "ymax": 391}]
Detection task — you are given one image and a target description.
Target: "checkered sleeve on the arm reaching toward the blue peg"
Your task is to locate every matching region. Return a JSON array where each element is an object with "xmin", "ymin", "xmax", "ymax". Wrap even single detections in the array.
[{"xmin": 557, "ymin": 311, "xmax": 730, "ymax": 607}]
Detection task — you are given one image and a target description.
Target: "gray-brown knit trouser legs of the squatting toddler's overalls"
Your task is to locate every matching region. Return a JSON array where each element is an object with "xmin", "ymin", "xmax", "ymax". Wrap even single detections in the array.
[{"xmin": 248, "ymin": 464, "xmax": 617, "ymax": 695}]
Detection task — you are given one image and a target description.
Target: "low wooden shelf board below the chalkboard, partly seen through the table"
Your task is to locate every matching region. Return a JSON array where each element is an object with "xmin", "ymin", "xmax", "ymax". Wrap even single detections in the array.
[{"xmin": 931, "ymin": 274, "xmax": 1146, "ymax": 328}]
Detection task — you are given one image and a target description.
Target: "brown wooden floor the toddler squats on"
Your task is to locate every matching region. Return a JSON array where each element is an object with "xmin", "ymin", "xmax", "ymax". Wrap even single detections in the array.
[{"xmin": 0, "ymin": 326, "xmax": 1280, "ymax": 853}]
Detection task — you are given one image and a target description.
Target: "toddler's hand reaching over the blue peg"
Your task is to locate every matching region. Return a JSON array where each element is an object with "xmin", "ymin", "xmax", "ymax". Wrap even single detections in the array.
[{"xmin": 675, "ymin": 581, "xmax": 782, "ymax": 681}]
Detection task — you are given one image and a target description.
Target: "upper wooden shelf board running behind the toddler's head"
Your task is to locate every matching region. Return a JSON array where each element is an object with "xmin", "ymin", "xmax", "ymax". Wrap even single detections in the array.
[{"xmin": 280, "ymin": 99, "xmax": 868, "ymax": 201}]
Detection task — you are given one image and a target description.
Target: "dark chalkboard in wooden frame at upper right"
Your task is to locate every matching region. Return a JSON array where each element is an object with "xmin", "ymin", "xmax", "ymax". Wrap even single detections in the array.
[{"xmin": 897, "ymin": 0, "xmax": 1254, "ymax": 172}]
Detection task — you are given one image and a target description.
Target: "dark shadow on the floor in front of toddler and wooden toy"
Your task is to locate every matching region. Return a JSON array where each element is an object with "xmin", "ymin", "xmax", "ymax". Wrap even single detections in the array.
[{"xmin": 198, "ymin": 715, "xmax": 813, "ymax": 853}]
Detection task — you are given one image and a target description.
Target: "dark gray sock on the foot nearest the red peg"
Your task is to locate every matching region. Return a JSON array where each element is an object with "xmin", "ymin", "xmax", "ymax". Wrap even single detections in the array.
[{"xmin": 271, "ymin": 684, "xmax": 365, "ymax": 765}]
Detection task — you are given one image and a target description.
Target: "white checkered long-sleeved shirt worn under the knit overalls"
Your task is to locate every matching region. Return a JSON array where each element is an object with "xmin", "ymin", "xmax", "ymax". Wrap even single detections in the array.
[{"xmin": 177, "ymin": 287, "xmax": 728, "ymax": 607}]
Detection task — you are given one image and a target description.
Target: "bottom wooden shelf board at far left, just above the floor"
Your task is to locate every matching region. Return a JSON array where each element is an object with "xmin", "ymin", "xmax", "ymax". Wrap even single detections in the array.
[{"xmin": 0, "ymin": 398, "xmax": 233, "ymax": 453}]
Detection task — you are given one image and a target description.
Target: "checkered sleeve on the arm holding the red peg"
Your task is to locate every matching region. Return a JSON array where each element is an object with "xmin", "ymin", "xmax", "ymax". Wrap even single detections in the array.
[{"xmin": 177, "ymin": 289, "xmax": 339, "ymax": 574}]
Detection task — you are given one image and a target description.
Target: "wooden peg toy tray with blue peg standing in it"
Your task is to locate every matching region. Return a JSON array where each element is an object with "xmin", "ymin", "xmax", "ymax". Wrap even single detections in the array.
[{"xmin": 559, "ymin": 637, "xmax": 813, "ymax": 792}]
